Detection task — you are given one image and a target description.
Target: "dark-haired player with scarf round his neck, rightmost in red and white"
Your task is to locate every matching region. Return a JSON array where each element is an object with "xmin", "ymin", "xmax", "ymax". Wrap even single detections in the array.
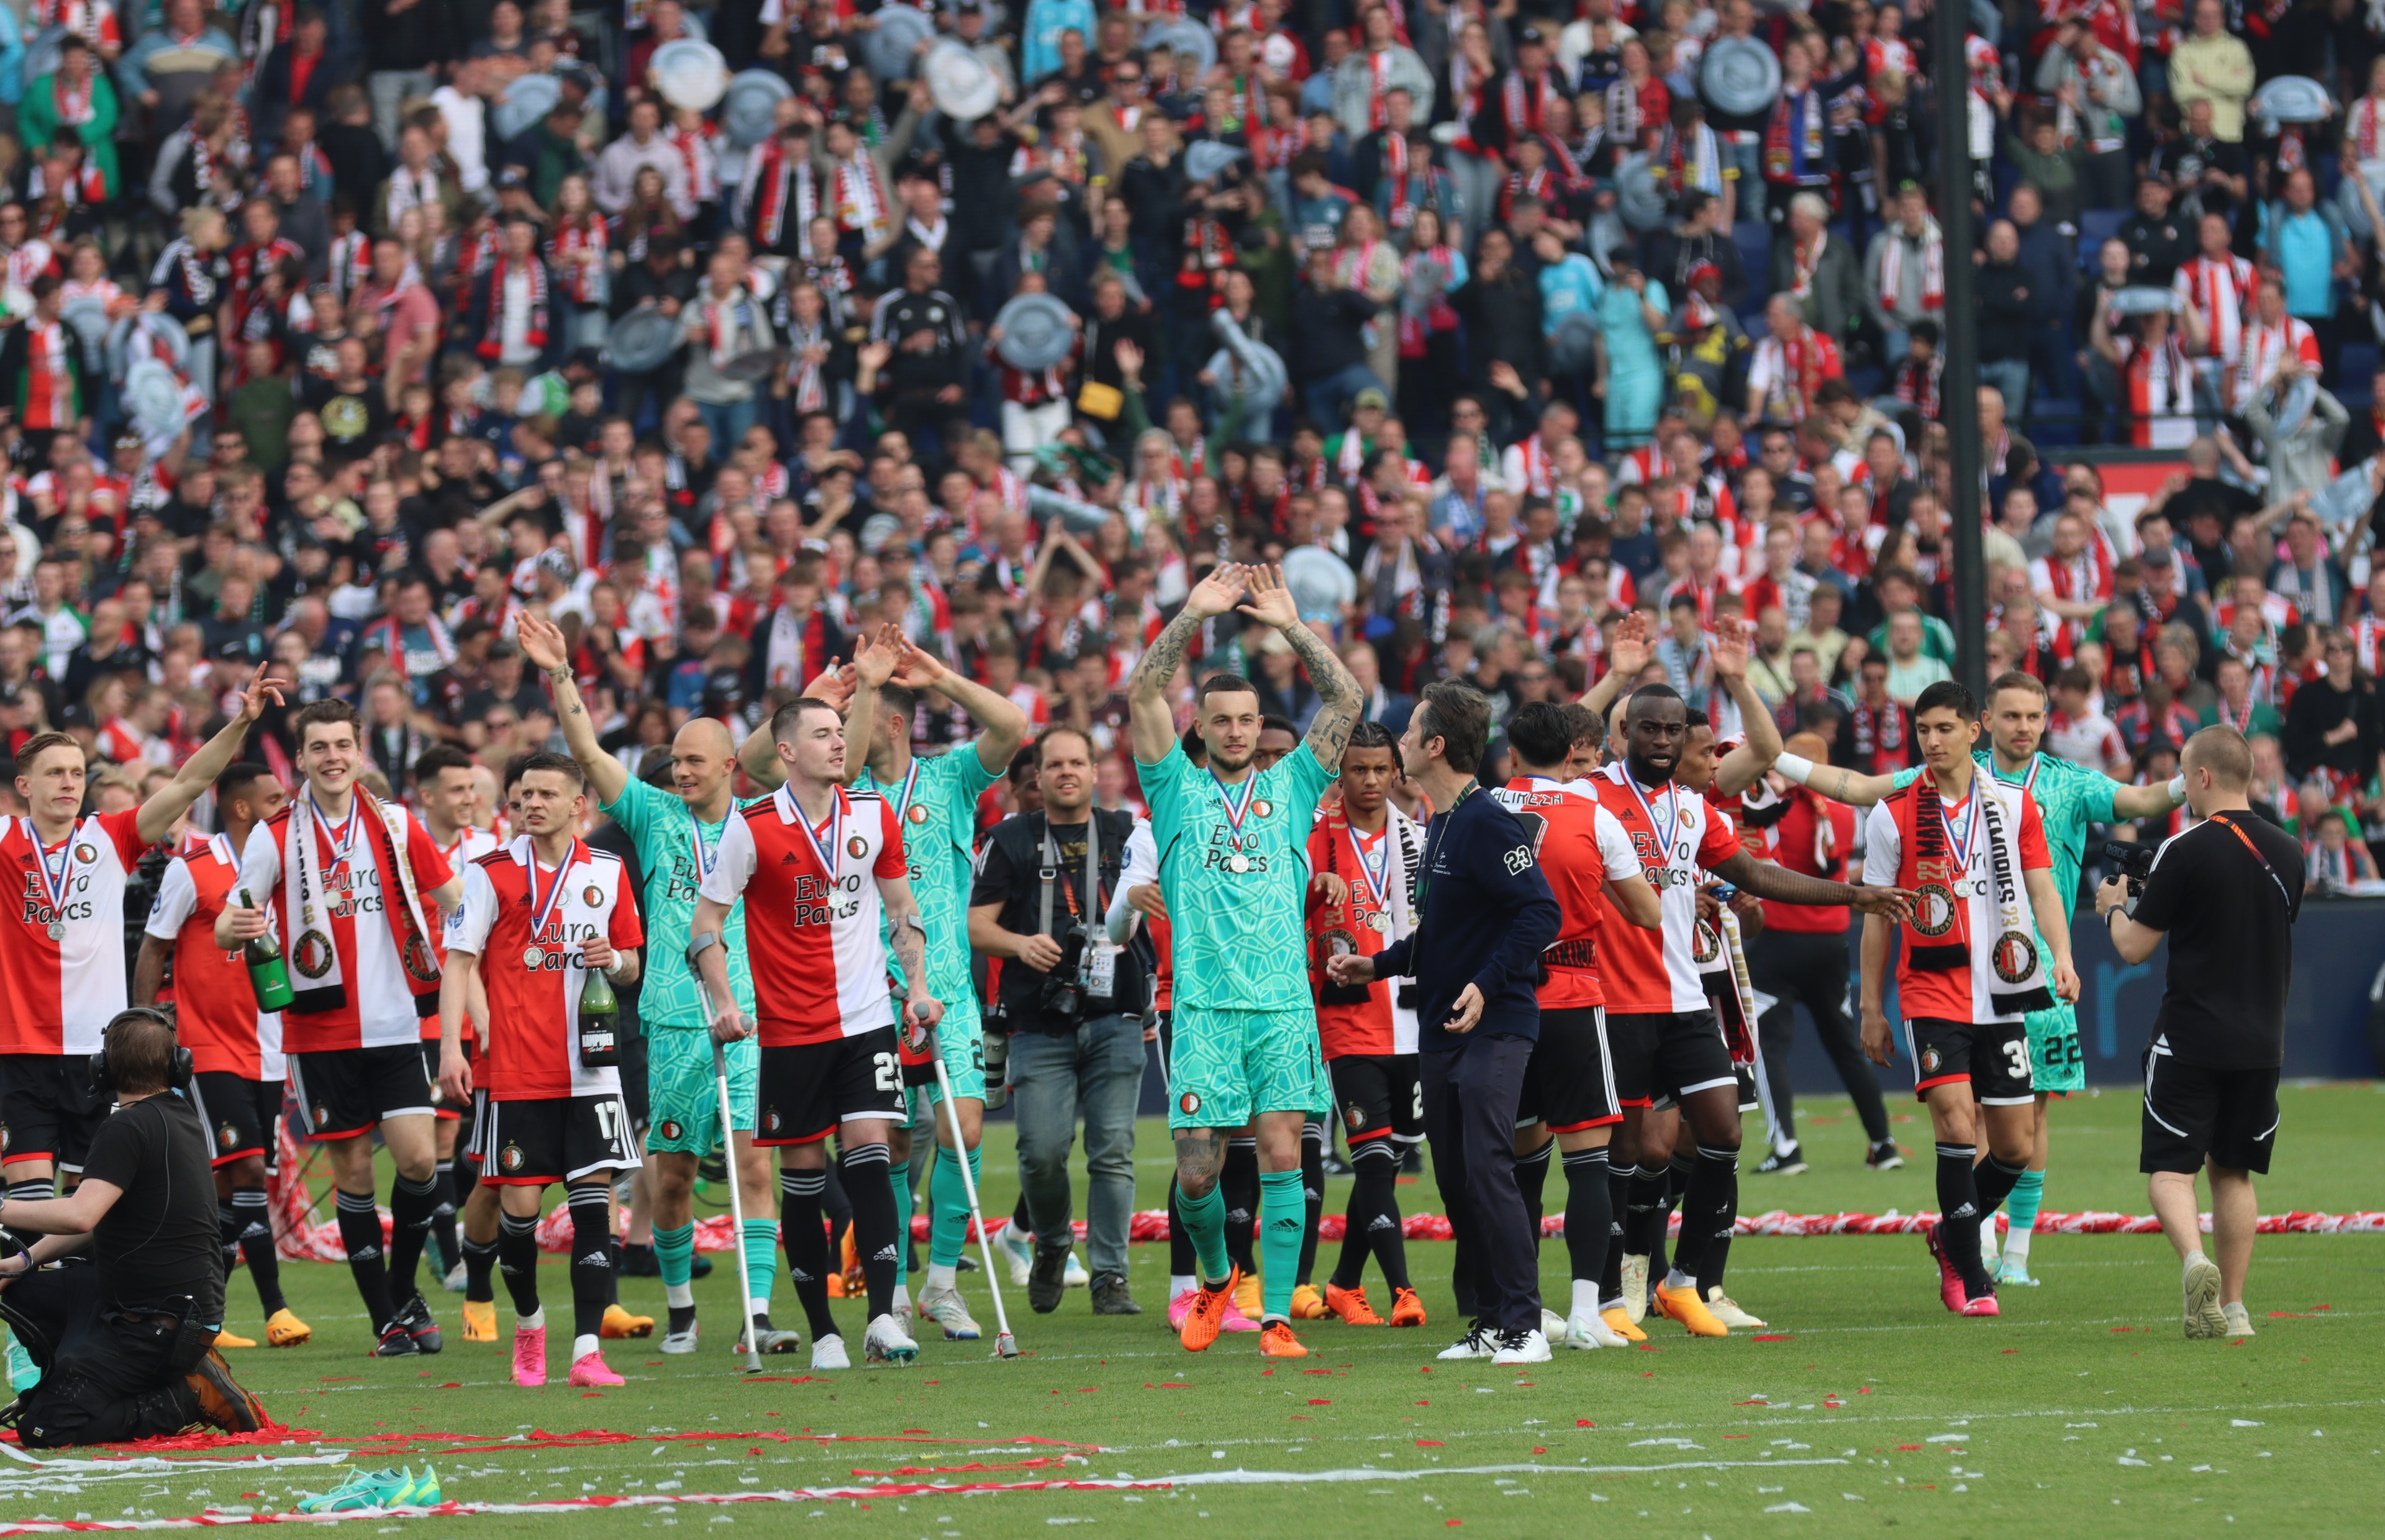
[{"xmin": 1863, "ymin": 679, "xmax": 2079, "ymax": 1316}]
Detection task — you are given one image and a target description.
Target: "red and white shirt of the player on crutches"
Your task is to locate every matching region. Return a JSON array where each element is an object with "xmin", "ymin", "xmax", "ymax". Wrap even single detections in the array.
[{"xmin": 699, "ymin": 787, "xmax": 911, "ymax": 1049}]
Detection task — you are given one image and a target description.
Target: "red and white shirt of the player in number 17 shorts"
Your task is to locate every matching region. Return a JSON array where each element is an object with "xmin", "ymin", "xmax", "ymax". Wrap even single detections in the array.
[{"xmin": 446, "ymin": 835, "xmax": 647, "ymax": 1102}]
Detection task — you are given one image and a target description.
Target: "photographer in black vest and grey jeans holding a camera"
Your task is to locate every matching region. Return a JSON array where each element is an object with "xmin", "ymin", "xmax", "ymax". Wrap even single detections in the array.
[{"xmin": 968, "ymin": 727, "xmax": 1147, "ymax": 1316}]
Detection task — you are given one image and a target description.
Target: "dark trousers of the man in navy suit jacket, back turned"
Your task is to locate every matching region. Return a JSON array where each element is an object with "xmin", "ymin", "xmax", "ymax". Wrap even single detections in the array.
[{"xmin": 1424, "ymin": 1032, "xmax": 1541, "ymax": 1330}]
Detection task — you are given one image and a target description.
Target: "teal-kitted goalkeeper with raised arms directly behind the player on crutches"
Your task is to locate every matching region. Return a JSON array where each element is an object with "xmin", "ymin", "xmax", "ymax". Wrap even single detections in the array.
[{"xmin": 732, "ymin": 636, "xmax": 1028, "ymax": 1342}]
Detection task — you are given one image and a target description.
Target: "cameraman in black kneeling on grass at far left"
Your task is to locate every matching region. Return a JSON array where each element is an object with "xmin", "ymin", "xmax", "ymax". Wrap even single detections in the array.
[{"xmin": 0, "ymin": 1006, "xmax": 265, "ymax": 1449}]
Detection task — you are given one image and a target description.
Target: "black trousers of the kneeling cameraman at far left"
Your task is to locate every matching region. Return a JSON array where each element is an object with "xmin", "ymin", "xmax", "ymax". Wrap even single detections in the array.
[{"xmin": 0, "ymin": 1264, "xmax": 198, "ymax": 1449}]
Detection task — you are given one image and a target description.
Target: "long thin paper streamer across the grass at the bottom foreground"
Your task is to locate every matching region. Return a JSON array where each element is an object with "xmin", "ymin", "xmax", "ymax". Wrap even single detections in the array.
[{"xmin": 0, "ymin": 1457, "xmax": 1848, "ymax": 1535}]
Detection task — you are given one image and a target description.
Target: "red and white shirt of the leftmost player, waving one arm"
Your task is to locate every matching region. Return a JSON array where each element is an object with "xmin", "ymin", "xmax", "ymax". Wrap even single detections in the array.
[{"xmin": 0, "ymin": 808, "xmax": 148, "ymax": 1063}]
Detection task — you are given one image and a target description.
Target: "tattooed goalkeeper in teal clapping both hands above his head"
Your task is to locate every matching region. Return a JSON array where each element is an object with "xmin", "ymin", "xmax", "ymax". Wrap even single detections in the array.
[{"xmin": 1128, "ymin": 563, "xmax": 1362, "ymax": 1359}]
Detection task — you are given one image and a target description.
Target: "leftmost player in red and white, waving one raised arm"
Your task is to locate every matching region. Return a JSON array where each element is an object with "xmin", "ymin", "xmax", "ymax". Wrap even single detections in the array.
[{"xmin": 0, "ymin": 665, "xmax": 281, "ymax": 1392}]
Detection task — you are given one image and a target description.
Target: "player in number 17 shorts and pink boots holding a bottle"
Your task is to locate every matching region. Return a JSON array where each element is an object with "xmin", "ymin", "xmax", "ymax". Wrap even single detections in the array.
[{"xmin": 439, "ymin": 753, "xmax": 647, "ymax": 1385}]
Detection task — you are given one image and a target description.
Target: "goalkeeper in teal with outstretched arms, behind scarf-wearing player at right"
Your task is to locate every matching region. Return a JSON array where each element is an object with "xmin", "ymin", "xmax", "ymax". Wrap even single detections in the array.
[{"xmin": 1772, "ymin": 673, "xmax": 2187, "ymax": 1285}]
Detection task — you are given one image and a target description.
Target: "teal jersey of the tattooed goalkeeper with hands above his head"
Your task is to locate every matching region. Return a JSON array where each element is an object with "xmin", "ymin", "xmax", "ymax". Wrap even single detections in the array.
[{"xmin": 1135, "ymin": 744, "xmax": 1333, "ymax": 1011}]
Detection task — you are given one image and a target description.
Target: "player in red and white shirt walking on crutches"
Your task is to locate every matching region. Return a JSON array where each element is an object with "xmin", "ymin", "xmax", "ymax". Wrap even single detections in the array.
[{"xmin": 687, "ymin": 696, "xmax": 945, "ymax": 1369}]
